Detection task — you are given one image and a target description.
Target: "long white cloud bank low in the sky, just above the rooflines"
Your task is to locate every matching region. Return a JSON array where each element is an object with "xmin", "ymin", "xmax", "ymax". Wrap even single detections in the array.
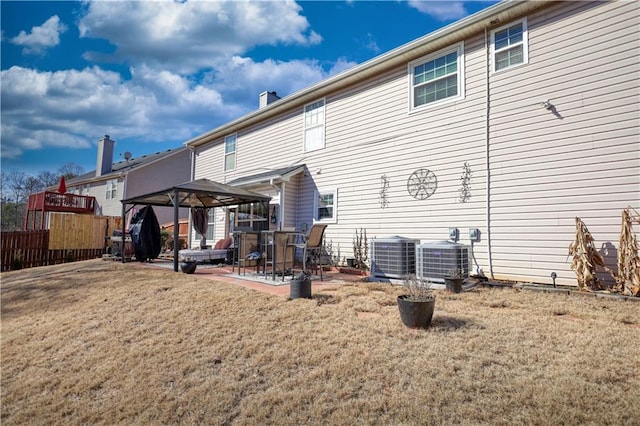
[{"xmin": 0, "ymin": 53, "xmax": 344, "ymax": 158}]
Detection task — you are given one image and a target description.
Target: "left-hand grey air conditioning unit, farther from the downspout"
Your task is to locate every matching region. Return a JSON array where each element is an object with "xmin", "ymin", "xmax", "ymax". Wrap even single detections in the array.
[{"xmin": 371, "ymin": 236, "xmax": 420, "ymax": 278}]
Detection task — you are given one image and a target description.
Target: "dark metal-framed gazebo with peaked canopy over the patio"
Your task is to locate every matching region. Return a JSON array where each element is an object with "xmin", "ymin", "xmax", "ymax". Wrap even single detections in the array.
[{"xmin": 121, "ymin": 179, "xmax": 271, "ymax": 272}]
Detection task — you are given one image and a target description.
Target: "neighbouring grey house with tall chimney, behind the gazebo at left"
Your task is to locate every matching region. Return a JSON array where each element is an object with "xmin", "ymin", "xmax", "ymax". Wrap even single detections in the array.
[{"xmin": 66, "ymin": 135, "xmax": 191, "ymax": 224}]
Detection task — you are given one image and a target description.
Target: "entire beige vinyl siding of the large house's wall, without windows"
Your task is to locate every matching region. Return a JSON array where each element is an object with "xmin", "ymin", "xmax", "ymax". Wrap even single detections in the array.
[{"xmin": 195, "ymin": 2, "xmax": 640, "ymax": 285}]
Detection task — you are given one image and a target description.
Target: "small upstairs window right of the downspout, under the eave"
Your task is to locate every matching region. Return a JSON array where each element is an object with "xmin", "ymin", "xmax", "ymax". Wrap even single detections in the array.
[{"xmin": 491, "ymin": 18, "xmax": 529, "ymax": 72}]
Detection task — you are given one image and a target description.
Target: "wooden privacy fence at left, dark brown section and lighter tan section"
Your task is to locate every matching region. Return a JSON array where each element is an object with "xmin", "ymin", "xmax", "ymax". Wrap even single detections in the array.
[{"xmin": 0, "ymin": 213, "xmax": 122, "ymax": 271}]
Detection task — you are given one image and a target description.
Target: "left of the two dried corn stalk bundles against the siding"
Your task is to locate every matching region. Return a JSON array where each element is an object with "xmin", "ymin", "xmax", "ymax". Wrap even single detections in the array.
[{"xmin": 569, "ymin": 217, "xmax": 605, "ymax": 290}]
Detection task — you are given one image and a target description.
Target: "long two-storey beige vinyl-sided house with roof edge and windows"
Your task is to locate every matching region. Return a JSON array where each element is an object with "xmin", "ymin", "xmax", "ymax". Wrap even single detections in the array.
[{"xmin": 186, "ymin": 1, "xmax": 640, "ymax": 285}]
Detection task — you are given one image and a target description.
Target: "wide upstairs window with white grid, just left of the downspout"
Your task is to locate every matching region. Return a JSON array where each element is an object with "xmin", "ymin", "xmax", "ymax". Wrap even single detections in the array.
[{"xmin": 409, "ymin": 43, "xmax": 464, "ymax": 110}]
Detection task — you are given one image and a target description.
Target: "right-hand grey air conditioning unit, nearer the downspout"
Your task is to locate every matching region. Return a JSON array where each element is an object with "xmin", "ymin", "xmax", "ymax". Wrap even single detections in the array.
[{"xmin": 416, "ymin": 241, "xmax": 470, "ymax": 283}]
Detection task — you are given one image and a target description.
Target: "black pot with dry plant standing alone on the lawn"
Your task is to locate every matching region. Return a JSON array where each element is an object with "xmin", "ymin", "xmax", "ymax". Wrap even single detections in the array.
[{"xmin": 398, "ymin": 275, "xmax": 436, "ymax": 328}]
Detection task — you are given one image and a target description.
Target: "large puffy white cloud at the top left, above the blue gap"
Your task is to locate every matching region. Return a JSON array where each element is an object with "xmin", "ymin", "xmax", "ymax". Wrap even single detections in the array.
[{"xmin": 79, "ymin": 1, "xmax": 322, "ymax": 74}]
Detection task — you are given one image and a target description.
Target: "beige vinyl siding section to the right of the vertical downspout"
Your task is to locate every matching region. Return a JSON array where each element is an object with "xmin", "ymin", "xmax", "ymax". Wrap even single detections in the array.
[{"xmin": 490, "ymin": 2, "xmax": 640, "ymax": 285}]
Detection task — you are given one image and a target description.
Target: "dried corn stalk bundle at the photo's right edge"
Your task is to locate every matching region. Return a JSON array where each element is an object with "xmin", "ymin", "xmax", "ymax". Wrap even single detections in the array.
[{"xmin": 616, "ymin": 207, "xmax": 640, "ymax": 296}]
